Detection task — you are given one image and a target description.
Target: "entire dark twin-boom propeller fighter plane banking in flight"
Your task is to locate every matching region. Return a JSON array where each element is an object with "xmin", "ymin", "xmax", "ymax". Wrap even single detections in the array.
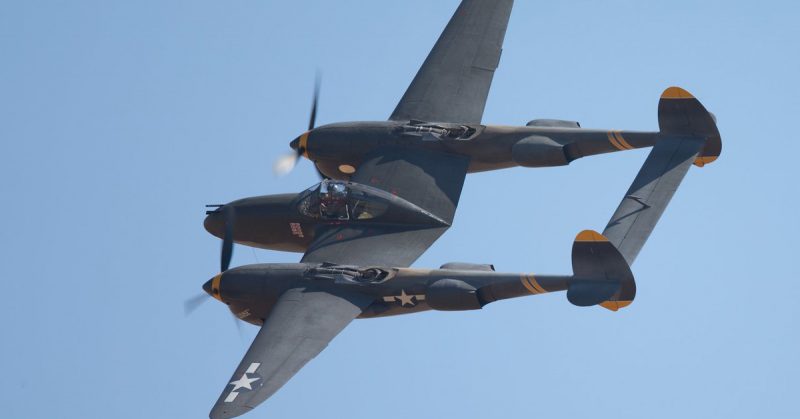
[{"xmin": 194, "ymin": 0, "xmax": 721, "ymax": 418}]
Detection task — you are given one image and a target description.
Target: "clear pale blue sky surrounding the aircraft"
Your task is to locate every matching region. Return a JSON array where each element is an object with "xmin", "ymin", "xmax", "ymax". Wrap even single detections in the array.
[{"xmin": 0, "ymin": 0, "xmax": 800, "ymax": 419}]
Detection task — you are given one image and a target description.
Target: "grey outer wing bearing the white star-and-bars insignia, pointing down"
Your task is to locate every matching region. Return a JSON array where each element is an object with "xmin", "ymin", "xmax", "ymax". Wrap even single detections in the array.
[{"xmin": 210, "ymin": 288, "xmax": 372, "ymax": 419}]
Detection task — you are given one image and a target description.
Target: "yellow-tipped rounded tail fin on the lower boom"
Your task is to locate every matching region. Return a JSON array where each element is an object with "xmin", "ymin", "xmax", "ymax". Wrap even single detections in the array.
[{"xmin": 567, "ymin": 230, "xmax": 636, "ymax": 311}]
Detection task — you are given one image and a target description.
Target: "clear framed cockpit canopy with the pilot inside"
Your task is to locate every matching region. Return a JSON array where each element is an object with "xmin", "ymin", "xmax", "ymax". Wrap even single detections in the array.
[{"xmin": 297, "ymin": 179, "xmax": 389, "ymax": 221}]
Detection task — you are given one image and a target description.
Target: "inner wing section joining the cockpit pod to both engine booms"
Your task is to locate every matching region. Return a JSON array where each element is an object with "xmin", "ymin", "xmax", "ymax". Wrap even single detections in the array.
[{"xmin": 302, "ymin": 147, "xmax": 469, "ymax": 267}]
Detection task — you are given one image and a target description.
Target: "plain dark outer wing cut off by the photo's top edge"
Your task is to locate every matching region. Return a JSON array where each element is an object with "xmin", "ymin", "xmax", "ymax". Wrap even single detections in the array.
[{"xmin": 389, "ymin": 0, "xmax": 514, "ymax": 124}]
